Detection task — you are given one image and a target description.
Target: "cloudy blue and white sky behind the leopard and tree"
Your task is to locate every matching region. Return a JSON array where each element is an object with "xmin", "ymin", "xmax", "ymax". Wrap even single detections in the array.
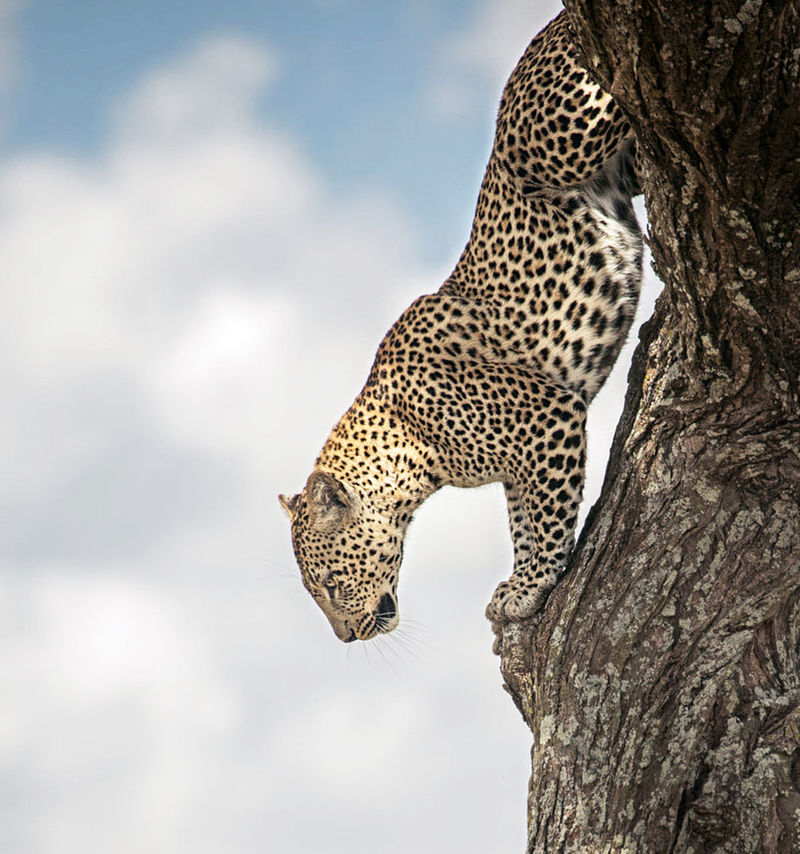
[{"xmin": 0, "ymin": 0, "xmax": 658, "ymax": 854}]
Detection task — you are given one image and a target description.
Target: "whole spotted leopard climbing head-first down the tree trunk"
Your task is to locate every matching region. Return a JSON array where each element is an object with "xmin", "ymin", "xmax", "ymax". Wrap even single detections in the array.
[{"xmin": 279, "ymin": 12, "xmax": 642, "ymax": 642}]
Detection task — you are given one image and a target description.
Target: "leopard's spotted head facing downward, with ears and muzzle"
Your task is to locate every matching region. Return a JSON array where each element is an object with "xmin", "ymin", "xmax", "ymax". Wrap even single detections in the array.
[{"xmin": 278, "ymin": 470, "xmax": 403, "ymax": 643}]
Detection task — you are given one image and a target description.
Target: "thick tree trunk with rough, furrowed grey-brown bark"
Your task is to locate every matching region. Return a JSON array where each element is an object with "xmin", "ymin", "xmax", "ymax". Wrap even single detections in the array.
[{"xmin": 496, "ymin": 0, "xmax": 800, "ymax": 854}]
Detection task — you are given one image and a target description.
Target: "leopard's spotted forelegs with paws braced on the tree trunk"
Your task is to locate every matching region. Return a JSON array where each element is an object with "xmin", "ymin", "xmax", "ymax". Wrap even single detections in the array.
[{"xmin": 486, "ymin": 392, "xmax": 585, "ymax": 623}]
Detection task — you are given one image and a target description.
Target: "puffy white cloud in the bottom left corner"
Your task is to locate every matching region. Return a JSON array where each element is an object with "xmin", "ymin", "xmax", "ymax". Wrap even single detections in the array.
[{"xmin": 0, "ymin": 566, "xmax": 241, "ymax": 852}]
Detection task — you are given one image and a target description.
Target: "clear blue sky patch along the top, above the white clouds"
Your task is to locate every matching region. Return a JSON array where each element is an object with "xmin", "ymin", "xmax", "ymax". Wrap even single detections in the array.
[{"xmin": 6, "ymin": 0, "xmax": 520, "ymax": 258}]
